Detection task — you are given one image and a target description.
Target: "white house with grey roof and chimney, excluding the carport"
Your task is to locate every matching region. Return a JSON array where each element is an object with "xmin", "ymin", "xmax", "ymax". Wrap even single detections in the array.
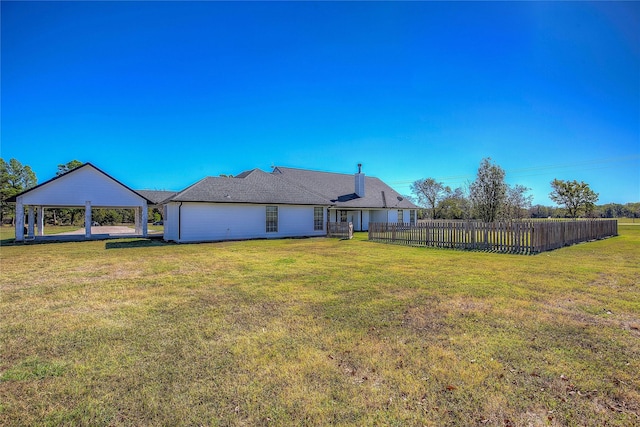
[{"xmin": 163, "ymin": 165, "xmax": 417, "ymax": 242}]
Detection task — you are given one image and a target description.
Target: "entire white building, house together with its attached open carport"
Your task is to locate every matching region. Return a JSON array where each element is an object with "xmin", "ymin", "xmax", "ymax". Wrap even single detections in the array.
[{"xmin": 10, "ymin": 163, "xmax": 417, "ymax": 242}]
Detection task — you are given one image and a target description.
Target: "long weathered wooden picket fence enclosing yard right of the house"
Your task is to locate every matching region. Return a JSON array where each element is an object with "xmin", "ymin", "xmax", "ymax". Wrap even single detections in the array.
[{"xmin": 369, "ymin": 219, "xmax": 618, "ymax": 254}]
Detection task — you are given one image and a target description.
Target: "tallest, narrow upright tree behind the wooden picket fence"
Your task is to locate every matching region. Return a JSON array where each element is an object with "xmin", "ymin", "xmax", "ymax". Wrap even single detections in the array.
[{"xmin": 469, "ymin": 157, "xmax": 507, "ymax": 222}]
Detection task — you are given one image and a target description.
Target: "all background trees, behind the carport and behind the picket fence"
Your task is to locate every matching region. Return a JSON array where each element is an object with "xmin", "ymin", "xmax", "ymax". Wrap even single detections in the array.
[{"xmin": 0, "ymin": 158, "xmax": 640, "ymax": 225}]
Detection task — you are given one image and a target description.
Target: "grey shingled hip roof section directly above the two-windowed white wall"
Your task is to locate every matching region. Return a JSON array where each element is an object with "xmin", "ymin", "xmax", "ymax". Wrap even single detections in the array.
[{"xmin": 167, "ymin": 169, "xmax": 331, "ymax": 206}]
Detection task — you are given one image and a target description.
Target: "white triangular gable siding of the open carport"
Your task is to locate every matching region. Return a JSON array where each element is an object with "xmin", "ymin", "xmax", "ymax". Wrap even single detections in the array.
[{"xmin": 22, "ymin": 166, "xmax": 146, "ymax": 208}]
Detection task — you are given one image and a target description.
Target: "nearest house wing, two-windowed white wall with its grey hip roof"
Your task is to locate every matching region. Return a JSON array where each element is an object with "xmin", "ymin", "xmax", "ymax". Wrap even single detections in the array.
[{"xmin": 163, "ymin": 169, "xmax": 331, "ymax": 242}]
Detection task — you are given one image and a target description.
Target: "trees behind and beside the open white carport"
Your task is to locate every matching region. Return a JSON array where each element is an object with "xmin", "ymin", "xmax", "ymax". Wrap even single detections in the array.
[{"xmin": 0, "ymin": 158, "xmax": 162, "ymax": 226}]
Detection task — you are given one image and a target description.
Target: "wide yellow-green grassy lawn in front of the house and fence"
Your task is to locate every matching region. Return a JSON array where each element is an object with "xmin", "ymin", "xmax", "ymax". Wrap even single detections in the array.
[{"xmin": 0, "ymin": 225, "xmax": 640, "ymax": 427}]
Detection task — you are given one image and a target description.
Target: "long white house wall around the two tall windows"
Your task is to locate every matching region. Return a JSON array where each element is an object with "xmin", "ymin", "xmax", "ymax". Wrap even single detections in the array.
[{"xmin": 164, "ymin": 202, "xmax": 326, "ymax": 242}]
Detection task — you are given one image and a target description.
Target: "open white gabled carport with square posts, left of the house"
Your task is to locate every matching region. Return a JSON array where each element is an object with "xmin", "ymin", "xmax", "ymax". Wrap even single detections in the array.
[{"xmin": 9, "ymin": 163, "xmax": 150, "ymax": 242}]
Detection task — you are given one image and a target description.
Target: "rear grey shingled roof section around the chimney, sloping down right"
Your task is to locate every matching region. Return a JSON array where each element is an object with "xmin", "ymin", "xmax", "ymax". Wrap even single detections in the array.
[{"xmin": 273, "ymin": 167, "xmax": 417, "ymax": 209}]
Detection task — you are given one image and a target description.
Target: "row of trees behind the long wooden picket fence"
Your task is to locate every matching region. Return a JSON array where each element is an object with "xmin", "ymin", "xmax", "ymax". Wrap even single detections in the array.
[{"xmin": 411, "ymin": 158, "xmax": 640, "ymax": 222}]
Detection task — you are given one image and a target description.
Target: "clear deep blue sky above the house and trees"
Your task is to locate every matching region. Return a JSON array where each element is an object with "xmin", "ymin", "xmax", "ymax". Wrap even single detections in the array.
[{"xmin": 0, "ymin": 1, "xmax": 640, "ymax": 205}]
